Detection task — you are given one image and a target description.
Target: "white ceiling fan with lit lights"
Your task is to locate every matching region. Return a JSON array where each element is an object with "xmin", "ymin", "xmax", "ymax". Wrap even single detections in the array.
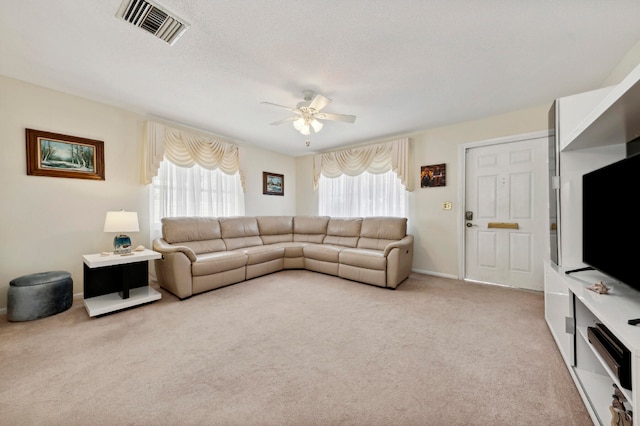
[{"xmin": 262, "ymin": 90, "xmax": 356, "ymax": 136}]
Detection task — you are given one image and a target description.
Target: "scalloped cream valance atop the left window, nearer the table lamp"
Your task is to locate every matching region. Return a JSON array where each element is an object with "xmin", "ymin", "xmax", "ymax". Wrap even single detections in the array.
[{"xmin": 143, "ymin": 121, "xmax": 245, "ymax": 190}]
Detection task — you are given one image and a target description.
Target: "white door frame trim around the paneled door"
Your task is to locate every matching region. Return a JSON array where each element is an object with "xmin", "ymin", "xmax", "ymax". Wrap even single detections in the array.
[{"xmin": 457, "ymin": 129, "xmax": 555, "ymax": 280}]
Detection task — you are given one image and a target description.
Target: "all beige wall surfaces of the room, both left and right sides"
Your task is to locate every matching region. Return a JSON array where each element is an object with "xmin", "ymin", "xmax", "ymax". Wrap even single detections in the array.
[{"xmin": 0, "ymin": 44, "xmax": 640, "ymax": 310}]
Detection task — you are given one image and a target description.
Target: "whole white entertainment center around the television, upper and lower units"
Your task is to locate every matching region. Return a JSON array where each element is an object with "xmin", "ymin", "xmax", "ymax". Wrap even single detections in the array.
[{"xmin": 544, "ymin": 60, "xmax": 640, "ymax": 426}]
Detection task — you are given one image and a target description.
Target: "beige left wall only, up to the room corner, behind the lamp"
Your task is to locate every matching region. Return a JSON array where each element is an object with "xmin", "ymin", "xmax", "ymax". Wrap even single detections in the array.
[{"xmin": 0, "ymin": 76, "xmax": 296, "ymax": 310}]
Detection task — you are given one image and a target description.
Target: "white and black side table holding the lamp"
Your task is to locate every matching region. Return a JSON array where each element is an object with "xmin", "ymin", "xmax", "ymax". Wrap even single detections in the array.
[{"xmin": 82, "ymin": 249, "xmax": 162, "ymax": 317}]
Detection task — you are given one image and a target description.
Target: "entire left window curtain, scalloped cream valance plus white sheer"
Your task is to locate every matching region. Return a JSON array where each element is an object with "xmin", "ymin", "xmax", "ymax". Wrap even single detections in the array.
[{"xmin": 142, "ymin": 121, "xmax": 244, "ymax": 241}]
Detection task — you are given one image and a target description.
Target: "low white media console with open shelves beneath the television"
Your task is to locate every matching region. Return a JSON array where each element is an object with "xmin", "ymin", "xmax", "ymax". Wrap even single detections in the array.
[{"xmin": 545, "ymin": 263, "xmax": 640, "ymax": 425}]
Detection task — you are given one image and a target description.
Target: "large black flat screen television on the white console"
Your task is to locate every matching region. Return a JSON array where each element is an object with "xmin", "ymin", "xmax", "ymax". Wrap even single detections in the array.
[{"xmin": 582, "ymin": 154, "xmax": 640, "ymax": 290}]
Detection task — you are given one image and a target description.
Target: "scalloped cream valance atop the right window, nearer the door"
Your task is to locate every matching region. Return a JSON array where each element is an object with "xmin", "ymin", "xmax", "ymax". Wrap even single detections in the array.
[{"xmin": 313, "ymin": 139, "xmax": 412, "ymax": 191}]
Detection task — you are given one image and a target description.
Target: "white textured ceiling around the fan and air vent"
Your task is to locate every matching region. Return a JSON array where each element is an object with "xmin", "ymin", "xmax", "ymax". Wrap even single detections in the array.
[{"xmin": 0, "ymin": 0, "xmax": 640, "ymax": 156}]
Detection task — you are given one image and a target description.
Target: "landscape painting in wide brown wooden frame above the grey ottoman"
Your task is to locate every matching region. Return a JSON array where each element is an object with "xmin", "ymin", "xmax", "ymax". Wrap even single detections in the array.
[{"xmin": 26, "ymin": 129, "xmax": 104, "ymax": 180}]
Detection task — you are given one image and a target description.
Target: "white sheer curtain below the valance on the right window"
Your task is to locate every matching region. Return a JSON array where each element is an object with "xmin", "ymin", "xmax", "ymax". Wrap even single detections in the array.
[{"xmin": 318, "ymin": 171, "xmax": 407, "ymax": 217}]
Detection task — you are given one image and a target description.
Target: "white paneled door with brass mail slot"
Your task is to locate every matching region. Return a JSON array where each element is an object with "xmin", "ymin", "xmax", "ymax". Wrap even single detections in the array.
[{"xmin": 464, "ymin": 137, "xmax": 549, "ymax": 291}]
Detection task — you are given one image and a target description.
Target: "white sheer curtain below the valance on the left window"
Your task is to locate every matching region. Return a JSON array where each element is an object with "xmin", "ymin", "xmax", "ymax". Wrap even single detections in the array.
[{"xmin": 151, "ymin": 160, "xmax": 244, "ymax": 225}]
